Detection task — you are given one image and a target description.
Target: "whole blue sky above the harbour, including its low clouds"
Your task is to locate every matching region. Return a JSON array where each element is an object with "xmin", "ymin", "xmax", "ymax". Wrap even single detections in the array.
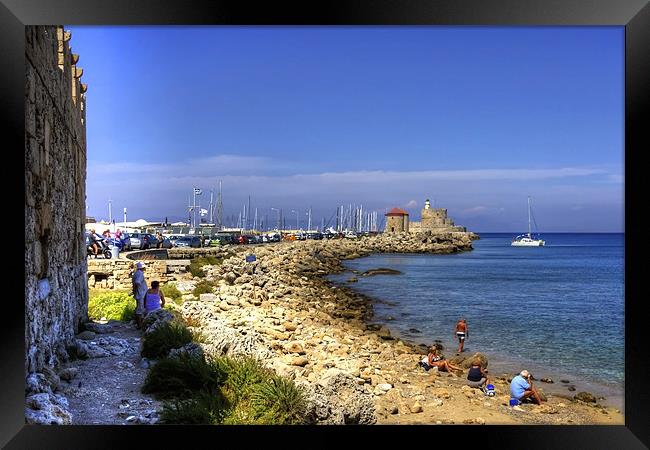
[{"xmin": 69, "ymin": 26, "xmax": 624, "ymax": 232}]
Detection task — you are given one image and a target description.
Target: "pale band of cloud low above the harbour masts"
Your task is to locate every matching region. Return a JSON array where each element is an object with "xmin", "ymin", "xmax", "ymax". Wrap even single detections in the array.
[{"xmin": 87, "ymin": 159, "xmax": 623, "ymax": 230}]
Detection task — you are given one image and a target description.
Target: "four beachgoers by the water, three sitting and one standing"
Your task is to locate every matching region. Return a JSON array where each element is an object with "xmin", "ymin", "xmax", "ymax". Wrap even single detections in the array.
[{"xmin": 419, "ymin": 319, "xmax": 542, "ymax": 410}]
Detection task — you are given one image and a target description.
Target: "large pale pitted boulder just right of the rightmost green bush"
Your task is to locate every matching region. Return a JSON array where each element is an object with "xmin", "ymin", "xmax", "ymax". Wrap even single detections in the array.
[{"xmin": 301, "ymin": 368, "xmax": 377, "ymax": 425}]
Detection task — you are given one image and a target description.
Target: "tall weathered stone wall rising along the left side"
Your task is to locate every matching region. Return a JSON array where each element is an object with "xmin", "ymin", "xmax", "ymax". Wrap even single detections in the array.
[{"xmin": 25, "ymin": 26, "xmax": 88, "ymax": 373}]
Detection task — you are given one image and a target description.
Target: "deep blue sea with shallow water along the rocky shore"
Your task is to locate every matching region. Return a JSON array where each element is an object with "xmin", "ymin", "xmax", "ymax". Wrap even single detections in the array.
[{"xmin": 329, "ymin": 233, "xmax": 625, "ymax": 409}]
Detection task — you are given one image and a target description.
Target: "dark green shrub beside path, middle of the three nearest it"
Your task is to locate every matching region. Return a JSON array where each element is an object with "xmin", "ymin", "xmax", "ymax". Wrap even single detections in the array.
[{"xmin": 142, "ymin": 353, "xmax": 227, "ymax": 399}]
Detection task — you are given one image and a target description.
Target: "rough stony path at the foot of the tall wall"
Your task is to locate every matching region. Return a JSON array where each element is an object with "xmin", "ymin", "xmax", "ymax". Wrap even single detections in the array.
[{"xmin": 59, "ymin": 321, "xmax": 161, "ymax": 425}]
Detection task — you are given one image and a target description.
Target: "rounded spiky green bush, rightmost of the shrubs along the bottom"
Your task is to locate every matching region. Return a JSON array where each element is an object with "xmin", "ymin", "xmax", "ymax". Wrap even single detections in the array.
[{"xmin": 251, "ymin": 376, "xmax": 307, "ymax": 425}]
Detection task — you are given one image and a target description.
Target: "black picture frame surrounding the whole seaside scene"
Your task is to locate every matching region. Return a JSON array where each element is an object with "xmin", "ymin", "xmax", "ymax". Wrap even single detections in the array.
[{"xmin": 0, "ymin": 0, "xmax": 650, "ymax": 449}]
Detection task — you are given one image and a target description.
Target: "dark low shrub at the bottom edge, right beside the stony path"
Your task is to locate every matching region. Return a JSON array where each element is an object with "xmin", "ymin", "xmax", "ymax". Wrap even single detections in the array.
[{"xmin": 160, "ymin": 392, "xmax": 229, "ymax": 425}]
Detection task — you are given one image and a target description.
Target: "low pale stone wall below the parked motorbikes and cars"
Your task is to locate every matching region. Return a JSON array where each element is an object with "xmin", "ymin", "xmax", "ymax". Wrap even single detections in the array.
[{"xmin": 88, "ymin": 258, "xmax": 192, "ymax": 289}]
